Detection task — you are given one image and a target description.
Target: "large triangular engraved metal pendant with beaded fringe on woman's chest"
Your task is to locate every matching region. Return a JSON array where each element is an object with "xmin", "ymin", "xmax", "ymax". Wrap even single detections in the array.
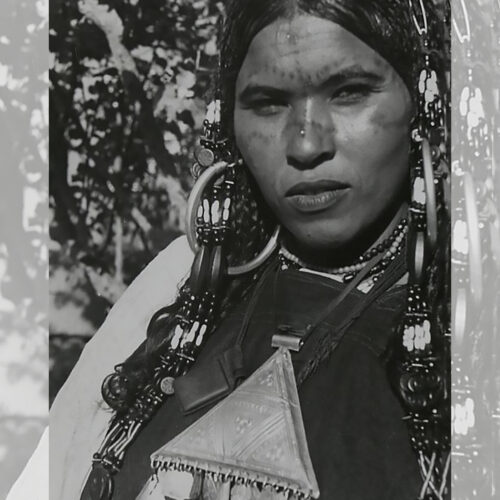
[{"xmin": 151, "ymin": 348, "xmax": 319, "ymax": 498}]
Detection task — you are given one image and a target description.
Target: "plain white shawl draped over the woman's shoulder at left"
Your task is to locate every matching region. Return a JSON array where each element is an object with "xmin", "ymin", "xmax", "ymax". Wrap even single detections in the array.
[{"xmin": 7, "ymin": 236, "xmax": 193, "ymax": 500}]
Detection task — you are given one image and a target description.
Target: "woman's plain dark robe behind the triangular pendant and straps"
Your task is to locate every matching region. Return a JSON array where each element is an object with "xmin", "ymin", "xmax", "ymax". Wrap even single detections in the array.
[{"xmin": 113, "ymin": 270, "xmax": 421, "ymax": 500}]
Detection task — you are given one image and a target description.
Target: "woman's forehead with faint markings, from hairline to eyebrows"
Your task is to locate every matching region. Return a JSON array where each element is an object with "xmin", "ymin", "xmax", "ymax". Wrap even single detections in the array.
[{"xmin": 238, "ymin": 15, "xmax": 392, "ymax": 90}]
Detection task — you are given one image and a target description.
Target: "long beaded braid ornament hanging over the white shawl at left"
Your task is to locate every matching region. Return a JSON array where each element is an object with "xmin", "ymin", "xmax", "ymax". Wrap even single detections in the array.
[{"xmin": 81, "ymin": 103, "xmax": 234, "ymax": 500}]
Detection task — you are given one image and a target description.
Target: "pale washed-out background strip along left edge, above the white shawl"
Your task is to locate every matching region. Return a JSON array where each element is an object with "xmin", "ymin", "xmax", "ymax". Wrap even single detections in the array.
[{"xmin": 0, "ymin": 0, "xmax": 48, "ymax": 499}]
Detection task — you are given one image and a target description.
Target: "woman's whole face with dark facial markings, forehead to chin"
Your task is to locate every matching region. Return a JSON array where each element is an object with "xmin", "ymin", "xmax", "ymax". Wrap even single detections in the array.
[{"xmin": 234, "ymin": 15, "xmax": 412, "ymax": 249}]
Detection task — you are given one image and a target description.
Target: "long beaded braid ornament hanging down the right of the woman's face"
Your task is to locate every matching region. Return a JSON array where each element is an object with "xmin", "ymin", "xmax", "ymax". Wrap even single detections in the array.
[{"xmin": 399, "ymin": 0, "xmax": 451, "ymax": 500}]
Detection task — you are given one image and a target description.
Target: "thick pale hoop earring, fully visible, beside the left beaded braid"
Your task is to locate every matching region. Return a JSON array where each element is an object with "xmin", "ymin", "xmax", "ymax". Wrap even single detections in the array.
[{"xmin": 186, "ymin": 161, "xmax": 280, "ymax": 276}]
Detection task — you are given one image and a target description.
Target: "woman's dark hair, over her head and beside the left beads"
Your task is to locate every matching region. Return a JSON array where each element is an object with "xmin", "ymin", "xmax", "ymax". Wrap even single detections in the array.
[{"xmin": 103, "ymin": 0, "xmax": 450, "ymax": 418}]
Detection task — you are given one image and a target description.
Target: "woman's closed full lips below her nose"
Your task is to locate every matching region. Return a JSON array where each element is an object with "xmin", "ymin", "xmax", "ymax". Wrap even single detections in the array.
[{"xmin": 286, "ymin": 181, "xmax": 349, "ymax": 213}]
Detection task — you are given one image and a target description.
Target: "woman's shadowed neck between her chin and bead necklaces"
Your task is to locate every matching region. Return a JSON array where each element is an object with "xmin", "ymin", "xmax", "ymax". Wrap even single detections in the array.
[{"xmin": 283, "ymin": 203, "xmax": 408, "ymax": 268}]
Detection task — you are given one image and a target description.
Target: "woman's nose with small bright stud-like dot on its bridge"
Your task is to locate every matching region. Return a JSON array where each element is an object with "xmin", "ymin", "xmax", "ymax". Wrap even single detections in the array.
[{"xmin": 287, "ymin": 99, "xmax": 336, "ymax": 169}]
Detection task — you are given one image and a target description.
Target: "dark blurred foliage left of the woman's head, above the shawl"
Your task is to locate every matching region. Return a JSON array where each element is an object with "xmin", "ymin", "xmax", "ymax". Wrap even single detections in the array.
[{"xmin": 49, "ymin": 0, "xmax": 221, "ymax": 402}]
